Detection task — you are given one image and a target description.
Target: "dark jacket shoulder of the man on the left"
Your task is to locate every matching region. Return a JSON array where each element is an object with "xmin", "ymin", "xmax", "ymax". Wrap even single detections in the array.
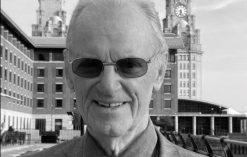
[{"xmin": 21, "ymin": 137, "xmax": 84, "ymax": 157}]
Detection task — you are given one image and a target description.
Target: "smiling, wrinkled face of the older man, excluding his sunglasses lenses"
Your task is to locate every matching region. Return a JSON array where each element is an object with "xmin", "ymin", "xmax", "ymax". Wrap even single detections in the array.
[{"xmin": 65, "ymin": 3, "xmax": 163, "ymax": 137}]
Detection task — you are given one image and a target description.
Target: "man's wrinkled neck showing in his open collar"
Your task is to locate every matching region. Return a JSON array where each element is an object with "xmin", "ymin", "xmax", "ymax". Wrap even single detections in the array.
[{"xmin": 90, "ymin": 119, "xmax": 148, "ymax": 156}]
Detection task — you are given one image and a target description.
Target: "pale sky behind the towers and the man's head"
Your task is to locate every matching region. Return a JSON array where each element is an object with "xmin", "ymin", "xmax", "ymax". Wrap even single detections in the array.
[{"xmin": 1, "ymin": 0, "xmax": 247, "ymax": 113}]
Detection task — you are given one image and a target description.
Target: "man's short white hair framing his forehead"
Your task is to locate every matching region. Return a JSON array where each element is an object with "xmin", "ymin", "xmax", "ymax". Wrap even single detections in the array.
[{"xmin": 66, "ymin": 0, "xmax": 168, "ymax": 68}]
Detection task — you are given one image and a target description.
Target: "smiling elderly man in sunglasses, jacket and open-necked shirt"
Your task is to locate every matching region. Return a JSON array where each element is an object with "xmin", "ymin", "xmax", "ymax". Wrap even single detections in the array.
[{"xmin": 24, "ymin": 0, "xmax": 206, "ymax": 157}]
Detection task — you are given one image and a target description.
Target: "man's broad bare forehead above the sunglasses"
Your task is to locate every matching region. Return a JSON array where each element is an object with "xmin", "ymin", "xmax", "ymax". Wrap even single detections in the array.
[{"xmin": 71, "ymin": 3, "xmax": 158, "ymax": 57}]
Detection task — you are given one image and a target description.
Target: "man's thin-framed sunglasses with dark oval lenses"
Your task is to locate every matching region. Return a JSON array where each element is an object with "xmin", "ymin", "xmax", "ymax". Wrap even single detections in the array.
[{"xmin": 72, "ymin": 58, "xmax": 151, "ymax": 78}]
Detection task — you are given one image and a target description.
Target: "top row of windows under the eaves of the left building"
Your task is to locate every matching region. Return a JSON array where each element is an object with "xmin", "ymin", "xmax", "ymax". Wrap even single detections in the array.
[{"xmin": 1, "ymin": 26, "xmax": 32, "ymax": 59}]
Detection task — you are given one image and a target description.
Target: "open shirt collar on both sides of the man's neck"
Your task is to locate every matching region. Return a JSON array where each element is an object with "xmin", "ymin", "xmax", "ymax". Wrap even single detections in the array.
[{"xmin": 82, "ymin": 119, "xmax": 157, "ymax": 157}]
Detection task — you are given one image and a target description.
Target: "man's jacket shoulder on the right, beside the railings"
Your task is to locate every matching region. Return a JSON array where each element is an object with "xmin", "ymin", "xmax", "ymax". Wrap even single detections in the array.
[{"xmin": 156, "ymin": 129, "xmax": 206, "ymax": 157}]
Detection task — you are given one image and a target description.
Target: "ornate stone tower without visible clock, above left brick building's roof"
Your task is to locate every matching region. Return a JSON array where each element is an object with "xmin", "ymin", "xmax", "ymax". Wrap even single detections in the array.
[{"xmin": 32, "ymin": 0, "xmax": 67, "ymax": 37}]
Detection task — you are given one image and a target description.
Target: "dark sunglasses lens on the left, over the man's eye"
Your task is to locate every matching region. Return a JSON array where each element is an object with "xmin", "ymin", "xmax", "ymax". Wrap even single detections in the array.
[{"xmin": 72, "ymin": 58, "xmax": 103, "ymax": 78}]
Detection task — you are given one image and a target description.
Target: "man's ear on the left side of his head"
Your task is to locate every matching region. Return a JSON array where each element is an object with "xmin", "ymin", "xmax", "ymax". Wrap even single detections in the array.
[{"xmin": 63, "ymin": 49, "xmax": 74, "ymax": 91}]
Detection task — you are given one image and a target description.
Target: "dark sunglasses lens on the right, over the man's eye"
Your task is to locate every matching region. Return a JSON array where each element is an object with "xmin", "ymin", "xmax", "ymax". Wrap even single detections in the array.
[{"xmin": 116, "ymin": 58, "xmax": 147, "ymax": 78}]
